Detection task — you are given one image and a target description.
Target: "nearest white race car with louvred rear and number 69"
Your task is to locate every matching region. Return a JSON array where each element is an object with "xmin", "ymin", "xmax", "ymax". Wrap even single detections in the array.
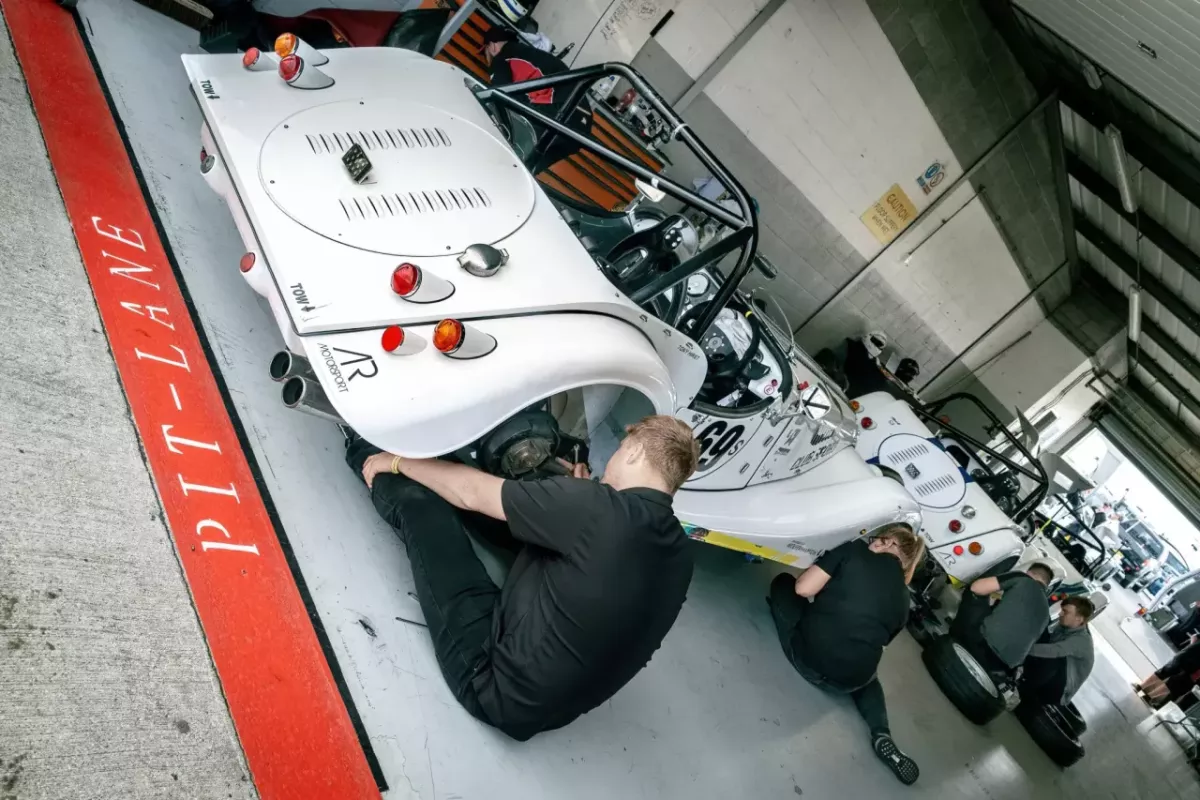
[{"xmin": 182, "ymin": 38, "xmax": 920, "ymax": 566}]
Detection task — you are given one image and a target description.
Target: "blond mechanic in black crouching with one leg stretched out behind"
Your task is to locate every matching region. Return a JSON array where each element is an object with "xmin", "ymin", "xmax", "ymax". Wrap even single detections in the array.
[{"xmin": 767, "ymin": 525, "xmax": 925, "ymax": 784}]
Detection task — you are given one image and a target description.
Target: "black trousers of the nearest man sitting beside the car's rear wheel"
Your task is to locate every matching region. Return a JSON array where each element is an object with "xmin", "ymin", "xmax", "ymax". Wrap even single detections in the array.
[{"xmin": 346, "ymin": 438, "xmax": 518, "ymax": 739}]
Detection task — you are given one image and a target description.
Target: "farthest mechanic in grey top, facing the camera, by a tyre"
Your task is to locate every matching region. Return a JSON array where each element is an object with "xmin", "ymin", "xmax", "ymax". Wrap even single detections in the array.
[{"xmin": 1020, "ymin": 597, "xmax": 1096, "ymax": 705}]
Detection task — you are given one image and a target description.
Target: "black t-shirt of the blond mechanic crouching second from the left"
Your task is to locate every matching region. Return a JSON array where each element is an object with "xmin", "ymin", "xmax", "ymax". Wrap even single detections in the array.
[{"xmin": 796, "ymin": 539, "xmax": 908, "ymax": 688}]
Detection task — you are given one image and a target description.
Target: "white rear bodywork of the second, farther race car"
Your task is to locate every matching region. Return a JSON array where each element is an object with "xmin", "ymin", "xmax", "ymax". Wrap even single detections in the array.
[{"xmin": 856, "ymin": 392, "xmax": 1025, "ymax": 582}]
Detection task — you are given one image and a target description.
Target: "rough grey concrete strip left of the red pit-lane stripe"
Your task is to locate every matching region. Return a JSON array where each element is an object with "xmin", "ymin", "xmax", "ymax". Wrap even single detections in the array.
[{"xmin": 0, "ymin": 7, "xmax": 254, "ymax": 800}]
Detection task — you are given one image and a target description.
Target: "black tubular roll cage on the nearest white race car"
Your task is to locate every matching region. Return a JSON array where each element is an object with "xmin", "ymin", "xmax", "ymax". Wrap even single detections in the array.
[{"xmin": 468, "ymin": 64, "xmax": 758, "ymax": 331}]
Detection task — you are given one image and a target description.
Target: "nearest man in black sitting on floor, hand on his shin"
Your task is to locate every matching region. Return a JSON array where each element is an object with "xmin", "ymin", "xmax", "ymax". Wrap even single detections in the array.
[{"xmin": 346, "ymin": 416, "xmax": 698, "ymax": 741}]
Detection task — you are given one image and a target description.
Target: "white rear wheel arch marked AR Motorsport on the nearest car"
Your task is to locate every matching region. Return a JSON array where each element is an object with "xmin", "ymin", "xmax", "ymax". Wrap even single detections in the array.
[{"xmin": 302, "ymin": 314, "xmax": 676, "ymax": 458}]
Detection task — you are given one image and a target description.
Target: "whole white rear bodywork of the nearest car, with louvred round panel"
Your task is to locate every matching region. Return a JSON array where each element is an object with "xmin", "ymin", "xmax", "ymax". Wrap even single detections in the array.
[{"xmin": 182, "ymin": 48, "xmax": 706, "ymax": 456}]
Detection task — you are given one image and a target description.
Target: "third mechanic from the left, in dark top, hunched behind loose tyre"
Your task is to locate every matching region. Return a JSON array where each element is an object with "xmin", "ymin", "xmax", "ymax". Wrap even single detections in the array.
[{"xmin": 950, "ymin": 564, "xmax": 1054, "ymax": 674}]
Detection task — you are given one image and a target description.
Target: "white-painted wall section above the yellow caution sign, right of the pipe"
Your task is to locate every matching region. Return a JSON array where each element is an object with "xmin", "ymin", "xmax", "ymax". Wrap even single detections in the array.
[{"xmin": 707, "ymin": 0, "xmax": 961, "ymax": 258}]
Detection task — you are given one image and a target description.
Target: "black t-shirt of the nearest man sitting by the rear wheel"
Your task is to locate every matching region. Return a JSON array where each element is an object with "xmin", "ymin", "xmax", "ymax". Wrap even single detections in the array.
[{"xmin": 479, "ymin": 477, "xmax": 692, "ymax": 738}]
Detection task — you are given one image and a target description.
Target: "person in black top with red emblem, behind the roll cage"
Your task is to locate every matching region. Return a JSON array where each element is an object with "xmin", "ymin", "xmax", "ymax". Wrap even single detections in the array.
[{"xmin": 484, "ymin": 25, "xmax": 592, "ymax": 175}]
